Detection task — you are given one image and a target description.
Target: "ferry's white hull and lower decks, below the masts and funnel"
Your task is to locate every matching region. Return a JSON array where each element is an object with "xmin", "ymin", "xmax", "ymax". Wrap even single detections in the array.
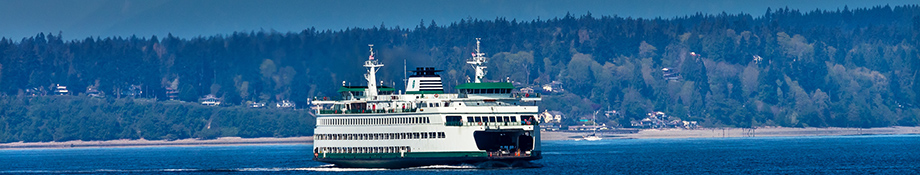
[{"xmin": 314, "ymin": 112, "xmax": 542, "ymax": 168}]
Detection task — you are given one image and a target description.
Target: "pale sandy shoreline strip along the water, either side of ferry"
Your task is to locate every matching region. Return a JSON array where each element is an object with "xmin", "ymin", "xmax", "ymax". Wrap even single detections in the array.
[{"xmin": 7, "ymin": 126, "xmax": 920, "ymax": 150}]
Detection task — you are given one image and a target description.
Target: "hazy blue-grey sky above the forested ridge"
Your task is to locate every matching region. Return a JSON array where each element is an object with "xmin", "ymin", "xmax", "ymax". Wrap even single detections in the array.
[{"xmin": 0, "ymin": 0, "xmax": 920, "ymax": 40}]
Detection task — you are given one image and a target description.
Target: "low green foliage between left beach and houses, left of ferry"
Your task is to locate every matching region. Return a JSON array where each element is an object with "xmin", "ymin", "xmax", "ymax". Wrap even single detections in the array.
[{"xmin": 0, "ymin": 96, "xmax": 315, "ymax": 143}]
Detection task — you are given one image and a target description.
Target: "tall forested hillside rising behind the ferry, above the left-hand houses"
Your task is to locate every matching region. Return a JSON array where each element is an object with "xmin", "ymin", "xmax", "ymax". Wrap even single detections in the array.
[{"xmin": 0, "ymin": 5, "xmax": 920, "ymax": 142}]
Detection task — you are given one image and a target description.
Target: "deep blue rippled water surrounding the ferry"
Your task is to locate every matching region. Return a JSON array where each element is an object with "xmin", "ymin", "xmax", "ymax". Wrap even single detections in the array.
[{"xmin": 0, "ymin": 135, "xmax": 920, "ymax": 174}]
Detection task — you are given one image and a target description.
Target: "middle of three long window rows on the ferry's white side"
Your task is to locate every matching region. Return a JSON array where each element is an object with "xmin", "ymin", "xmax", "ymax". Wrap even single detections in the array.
[{"xmin": 313, "ymin": 132, "xmax": 445, "ymax": 140}]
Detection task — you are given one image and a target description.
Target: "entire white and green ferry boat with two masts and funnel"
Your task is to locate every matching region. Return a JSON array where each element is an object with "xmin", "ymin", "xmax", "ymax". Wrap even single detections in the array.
[{"xmin": 312, "ymin": 38, "xmax": 542, "ymax": 168}]
